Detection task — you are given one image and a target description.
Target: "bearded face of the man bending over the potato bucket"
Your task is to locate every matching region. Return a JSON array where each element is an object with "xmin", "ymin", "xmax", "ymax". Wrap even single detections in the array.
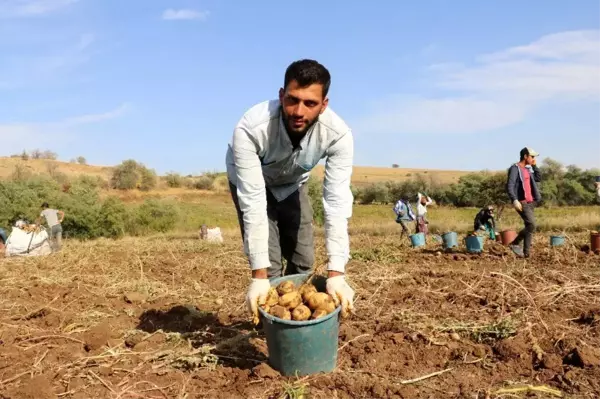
[{"xmin": 279, "ymin": 80, "xmax": 329, "ymax": 136}]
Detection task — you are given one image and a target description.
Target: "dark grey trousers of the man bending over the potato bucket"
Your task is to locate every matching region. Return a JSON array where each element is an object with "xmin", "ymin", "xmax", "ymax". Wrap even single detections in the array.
[{"xmin": 229, "ymin": 183, "xmax": 315, "ymax": 278}]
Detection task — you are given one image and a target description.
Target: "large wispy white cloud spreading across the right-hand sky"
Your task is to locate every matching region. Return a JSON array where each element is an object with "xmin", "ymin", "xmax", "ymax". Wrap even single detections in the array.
[{"xmin": 358, "ymin": 30, "xmax": 600, "ymax": 134}]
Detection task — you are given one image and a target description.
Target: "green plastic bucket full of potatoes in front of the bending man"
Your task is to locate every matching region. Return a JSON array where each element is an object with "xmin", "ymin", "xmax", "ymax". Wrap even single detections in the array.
[{"xmin": 259, "ymin": 274, "xmax": 341, "ymax": 376}]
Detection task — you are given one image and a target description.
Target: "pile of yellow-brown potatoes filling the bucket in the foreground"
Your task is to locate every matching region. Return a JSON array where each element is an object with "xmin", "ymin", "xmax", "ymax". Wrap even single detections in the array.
[{"xmin": 261, "ymin": 280, "xmax": 335, "ymax": 321}]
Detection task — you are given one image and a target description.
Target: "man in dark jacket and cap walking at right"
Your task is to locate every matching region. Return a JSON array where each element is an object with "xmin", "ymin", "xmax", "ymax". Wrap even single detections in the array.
[{"xmin": 506, "ymin": 147, "xmax": 542, "ymax": 258}]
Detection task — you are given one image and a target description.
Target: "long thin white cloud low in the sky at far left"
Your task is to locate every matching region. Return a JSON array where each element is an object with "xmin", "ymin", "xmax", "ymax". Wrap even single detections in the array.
[{"xmin": 0, "ymin": 103, "xmax": 130, "ymax": 154}]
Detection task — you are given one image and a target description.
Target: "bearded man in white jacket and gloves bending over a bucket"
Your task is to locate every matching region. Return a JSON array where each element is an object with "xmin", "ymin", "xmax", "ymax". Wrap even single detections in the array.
[{"xmin": 226, "ymin": 60, "xmax": 354, "ymax": 322}]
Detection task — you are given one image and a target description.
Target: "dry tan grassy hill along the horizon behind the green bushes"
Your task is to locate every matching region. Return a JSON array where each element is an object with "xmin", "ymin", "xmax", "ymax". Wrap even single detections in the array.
[{"xmin": 0, "ymin": 157, "xmax": 478, "ymax": 187}]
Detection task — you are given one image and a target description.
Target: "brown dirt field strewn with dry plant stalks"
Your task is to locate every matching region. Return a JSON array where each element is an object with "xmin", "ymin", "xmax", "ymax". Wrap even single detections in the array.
[{"xmin": 0, "ymin": 233, "xmax": 600, "ymax": 399}]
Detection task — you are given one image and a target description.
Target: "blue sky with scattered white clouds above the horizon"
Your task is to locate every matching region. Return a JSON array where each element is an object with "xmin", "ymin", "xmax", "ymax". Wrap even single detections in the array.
[{"xmin": 0, "ymin": 0, "xmax": 600, "ymax": 174}]
